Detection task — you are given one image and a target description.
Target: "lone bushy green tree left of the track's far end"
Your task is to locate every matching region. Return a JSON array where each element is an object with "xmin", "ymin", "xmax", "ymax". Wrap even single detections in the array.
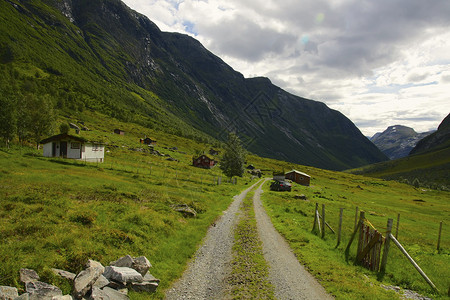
[{"xmin": 220, "ymin": 133, "xmax": 247, "ymax": 178}]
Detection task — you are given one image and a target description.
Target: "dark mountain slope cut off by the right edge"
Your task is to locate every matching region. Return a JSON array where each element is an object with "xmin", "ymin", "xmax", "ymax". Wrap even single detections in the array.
[{"xmin": 410, "ymin": 114, "xmax": 450, "ymax": 155}]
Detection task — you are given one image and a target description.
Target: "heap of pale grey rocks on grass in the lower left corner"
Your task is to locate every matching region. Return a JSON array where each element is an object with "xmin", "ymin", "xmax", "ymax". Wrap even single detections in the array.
[{"xmin": 0, "ymin": 255, "xmax": 159, "ymax": 300}]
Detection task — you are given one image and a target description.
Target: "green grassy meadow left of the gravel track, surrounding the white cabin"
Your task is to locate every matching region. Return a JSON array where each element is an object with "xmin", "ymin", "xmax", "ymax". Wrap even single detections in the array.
[{"xmin": 0, "ymin": 114, "xmax": 250, "ymax": 299}]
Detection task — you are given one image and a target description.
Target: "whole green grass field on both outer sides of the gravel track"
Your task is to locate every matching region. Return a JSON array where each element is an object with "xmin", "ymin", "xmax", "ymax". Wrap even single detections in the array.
[{"xmin": 0, "ymin": 111, "xmax": 450, "ymax": 299}]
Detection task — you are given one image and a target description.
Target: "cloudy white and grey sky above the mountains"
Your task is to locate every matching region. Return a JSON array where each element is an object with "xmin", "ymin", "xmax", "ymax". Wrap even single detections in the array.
[{"xmin": 123, "ymin": 0, "xmax": 450, "ymax": 136}]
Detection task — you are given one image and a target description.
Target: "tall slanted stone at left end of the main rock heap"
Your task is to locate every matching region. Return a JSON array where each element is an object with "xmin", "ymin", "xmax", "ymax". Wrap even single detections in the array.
[{"xmin": 73, "ymin": 260, "xmax": 105, "ymax": 299}]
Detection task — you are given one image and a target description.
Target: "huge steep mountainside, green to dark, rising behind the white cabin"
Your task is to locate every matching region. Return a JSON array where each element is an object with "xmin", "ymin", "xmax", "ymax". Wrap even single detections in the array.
[{"xmin": 0, "ymin": 0, "xmax": 387, "ymax": 170}]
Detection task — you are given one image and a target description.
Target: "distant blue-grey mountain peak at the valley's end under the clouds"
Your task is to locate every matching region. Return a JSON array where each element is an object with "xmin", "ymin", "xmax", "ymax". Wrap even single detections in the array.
[{"xmin": 370, "ymin": 125, "xmax": 433, "ymax": 159}]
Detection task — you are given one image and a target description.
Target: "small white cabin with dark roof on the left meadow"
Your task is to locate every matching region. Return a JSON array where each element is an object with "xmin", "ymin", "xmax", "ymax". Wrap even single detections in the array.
[{"xmin": 40, "ymin": 133, "xmax": 105, "ymax": 162}]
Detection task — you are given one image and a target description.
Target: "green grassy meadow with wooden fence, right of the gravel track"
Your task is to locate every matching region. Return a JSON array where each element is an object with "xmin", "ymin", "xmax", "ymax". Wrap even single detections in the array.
[{"xmin": 262, "ymin": 163, "xmax": 450, "ymax": 299}]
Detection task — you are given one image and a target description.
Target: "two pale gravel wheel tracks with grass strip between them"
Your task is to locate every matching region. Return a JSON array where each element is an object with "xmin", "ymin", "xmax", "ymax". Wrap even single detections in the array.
[{"xmin": 166, "ymin": 179, "xmax": 332, "ymax": 300}]
